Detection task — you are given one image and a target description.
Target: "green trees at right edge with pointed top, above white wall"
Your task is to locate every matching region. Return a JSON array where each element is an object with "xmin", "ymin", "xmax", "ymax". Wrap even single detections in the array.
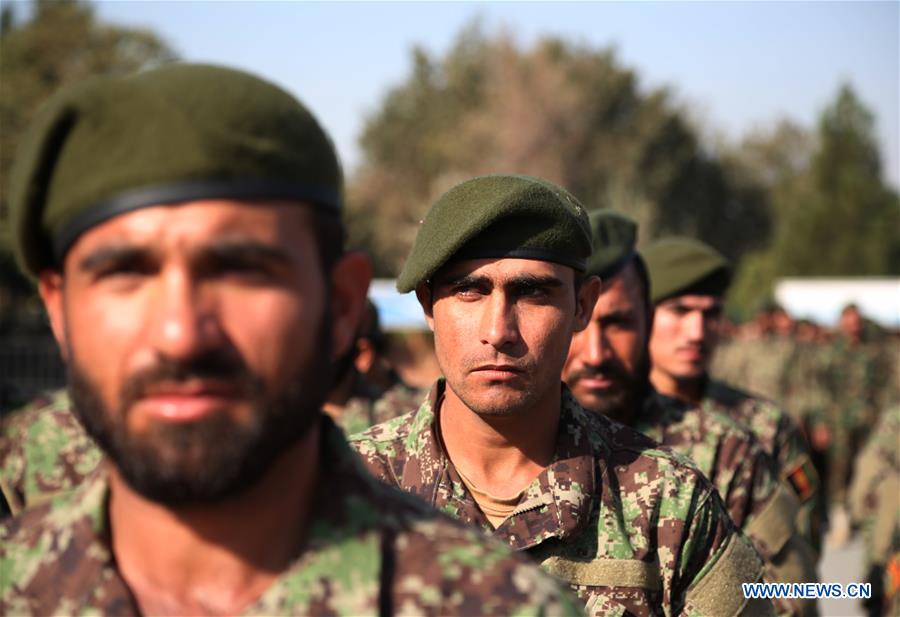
[{"xmin": 732, "ymin": 86, "xmax": 900, "ymax": 318}]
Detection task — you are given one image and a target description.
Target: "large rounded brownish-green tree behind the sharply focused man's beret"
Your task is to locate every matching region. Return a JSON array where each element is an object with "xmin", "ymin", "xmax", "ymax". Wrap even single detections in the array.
[{"xmin": 348, "ymin": 23, "xmax": 768, "ymax": 275}]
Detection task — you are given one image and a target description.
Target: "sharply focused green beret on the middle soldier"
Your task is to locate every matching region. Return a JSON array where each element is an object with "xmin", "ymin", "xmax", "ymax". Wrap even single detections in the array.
[{"xmin": 397, "ymin": 175, "xmax": 591, "ymax": 293}]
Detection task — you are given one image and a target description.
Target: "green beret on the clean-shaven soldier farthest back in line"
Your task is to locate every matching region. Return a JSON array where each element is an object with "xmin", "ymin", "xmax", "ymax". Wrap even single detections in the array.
[{"xmin": 641, "ymin": 237, "xmax": 731, "ymax": 304}]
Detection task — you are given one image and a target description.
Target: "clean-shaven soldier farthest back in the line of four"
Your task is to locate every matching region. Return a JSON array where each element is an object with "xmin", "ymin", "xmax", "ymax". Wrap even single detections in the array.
[{"xmin": 642, "ymin": 237, "xmax": 820, "ymax": 547}]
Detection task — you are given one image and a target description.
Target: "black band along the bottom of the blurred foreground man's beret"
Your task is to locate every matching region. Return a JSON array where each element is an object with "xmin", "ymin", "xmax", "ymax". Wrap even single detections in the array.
[{"xmin": 53, "ymin": 178, "xmax": 341, "ymax": 263}]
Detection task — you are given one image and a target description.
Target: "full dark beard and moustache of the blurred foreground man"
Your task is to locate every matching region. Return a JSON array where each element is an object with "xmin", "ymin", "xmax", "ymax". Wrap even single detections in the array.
[{"xmin": 68, "ymin": 316, "xmax": 332, "ymax": 506}]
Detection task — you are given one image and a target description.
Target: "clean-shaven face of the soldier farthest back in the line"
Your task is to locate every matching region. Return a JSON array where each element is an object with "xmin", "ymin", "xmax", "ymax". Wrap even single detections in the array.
[{"xmin": 650, "ymin": 295, "xmax": 722, "ymax": 381}]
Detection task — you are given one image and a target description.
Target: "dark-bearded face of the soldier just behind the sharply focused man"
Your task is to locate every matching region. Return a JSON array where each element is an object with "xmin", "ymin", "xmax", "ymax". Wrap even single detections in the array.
[{"xmin": 563, "ymin": 263, "xmax": 649, "ymax": 421}]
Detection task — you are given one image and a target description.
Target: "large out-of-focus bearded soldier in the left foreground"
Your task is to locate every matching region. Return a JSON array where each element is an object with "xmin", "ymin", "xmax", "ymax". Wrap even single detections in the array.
[{"xmin": 0, "ymin": 65, "xmax": 574, "ymax": 615}]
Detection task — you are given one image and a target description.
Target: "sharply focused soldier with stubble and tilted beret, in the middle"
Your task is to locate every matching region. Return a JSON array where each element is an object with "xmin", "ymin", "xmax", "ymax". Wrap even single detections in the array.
[{"xmin": 351, "ymin": 175, "xmax": 771, "ymax": 615}]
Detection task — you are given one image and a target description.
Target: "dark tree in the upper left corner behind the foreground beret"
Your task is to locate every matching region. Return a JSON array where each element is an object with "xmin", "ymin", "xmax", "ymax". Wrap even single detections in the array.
[{"xmin": 0, "ymin": 0, "xmax": 175, "ymax": 324}]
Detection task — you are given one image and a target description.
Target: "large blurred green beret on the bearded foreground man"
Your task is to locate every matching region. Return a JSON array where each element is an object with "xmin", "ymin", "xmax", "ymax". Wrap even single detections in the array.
[{"xmin": 10, "ymin": 64, "xmax": 342, "ymax": 275}]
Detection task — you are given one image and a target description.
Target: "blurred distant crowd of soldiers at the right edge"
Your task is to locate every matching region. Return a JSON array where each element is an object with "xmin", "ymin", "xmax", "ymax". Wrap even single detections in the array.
[{"xmin": 713, "ymin": 304, "xmax": 900, "ymax": 528}]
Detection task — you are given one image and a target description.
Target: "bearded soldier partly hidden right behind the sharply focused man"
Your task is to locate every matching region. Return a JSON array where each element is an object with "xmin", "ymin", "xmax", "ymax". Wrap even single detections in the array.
[{"xmin": 563, "ymin": 210, "xmax": 816, "ymax": 613}]
